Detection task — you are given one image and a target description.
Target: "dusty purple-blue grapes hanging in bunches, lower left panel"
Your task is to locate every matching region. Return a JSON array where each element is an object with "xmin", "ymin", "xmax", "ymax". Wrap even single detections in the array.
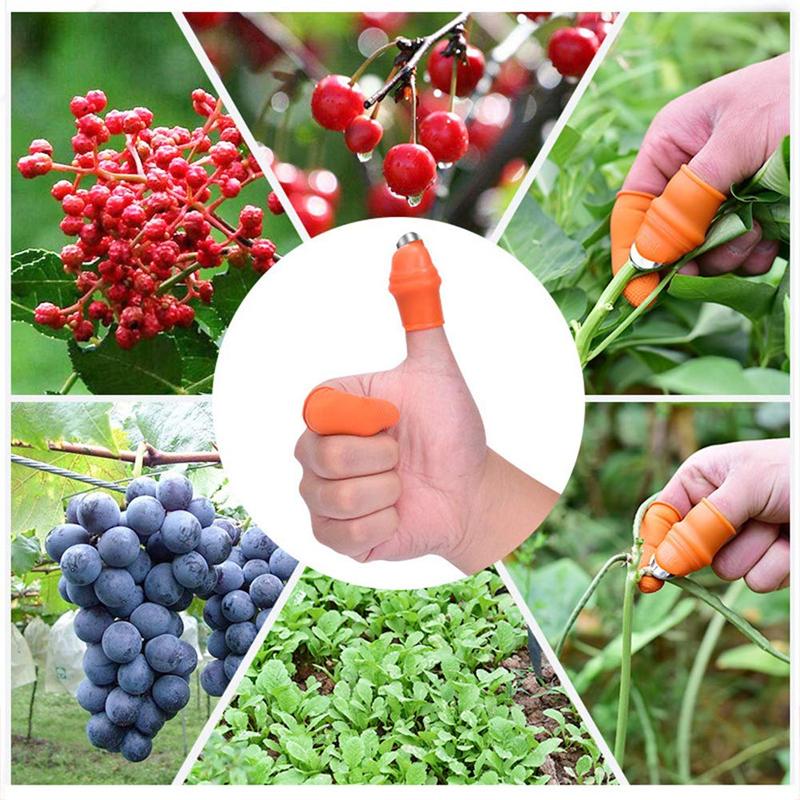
[{"xmin": 50, "ymin": 472, "xmax": 297, "ymax": 762}]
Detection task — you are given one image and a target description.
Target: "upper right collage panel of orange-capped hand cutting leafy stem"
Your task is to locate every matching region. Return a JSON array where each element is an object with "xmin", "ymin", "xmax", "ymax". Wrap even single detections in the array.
[{"xmin": 500, "ymin": 11, "xmax": 790, "ymax": 396}]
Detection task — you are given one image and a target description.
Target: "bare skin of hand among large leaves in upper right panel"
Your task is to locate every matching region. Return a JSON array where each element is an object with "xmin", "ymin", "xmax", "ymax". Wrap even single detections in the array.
[{"xmin": 612, "ymin": 53, "xmax": 789, "ymax": 282}]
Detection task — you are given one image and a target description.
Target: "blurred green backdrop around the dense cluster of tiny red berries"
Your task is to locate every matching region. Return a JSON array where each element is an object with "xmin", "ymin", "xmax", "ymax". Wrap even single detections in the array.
[{"xmin": 11, "ymin": 13, "xmax": 299, "ymax": 395}]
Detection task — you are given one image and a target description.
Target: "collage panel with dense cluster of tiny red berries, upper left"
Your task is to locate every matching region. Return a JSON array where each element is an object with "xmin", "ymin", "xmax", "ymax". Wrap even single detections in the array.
[{"xmin": 11, "ymin": 12, "xmax": 300, "ymax": 395}]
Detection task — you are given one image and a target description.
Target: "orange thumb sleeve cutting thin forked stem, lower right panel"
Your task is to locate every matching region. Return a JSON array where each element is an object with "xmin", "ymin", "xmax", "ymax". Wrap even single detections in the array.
[{"xmin": 656, "ymin": 498, "xmax": 736, "ymax": 576}]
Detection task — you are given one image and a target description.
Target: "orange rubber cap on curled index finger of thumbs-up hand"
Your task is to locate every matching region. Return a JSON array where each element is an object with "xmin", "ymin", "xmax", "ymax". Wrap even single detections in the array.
[{"xmin": 303, "ymin": 386, "xmax": 400, "ymax": 436}]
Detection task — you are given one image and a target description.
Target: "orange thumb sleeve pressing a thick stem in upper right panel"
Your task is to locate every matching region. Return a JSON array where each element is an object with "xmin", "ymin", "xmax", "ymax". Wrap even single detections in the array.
[{"xmin": 635, "ymin": 164, "xmax": 725, "ymax": 264}]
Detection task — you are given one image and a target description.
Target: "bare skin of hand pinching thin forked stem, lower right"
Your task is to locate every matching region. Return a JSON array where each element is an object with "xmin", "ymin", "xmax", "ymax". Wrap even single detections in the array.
[{"xmin": 656, "ymin": 439, "xmax": 791, "ymax": 592}]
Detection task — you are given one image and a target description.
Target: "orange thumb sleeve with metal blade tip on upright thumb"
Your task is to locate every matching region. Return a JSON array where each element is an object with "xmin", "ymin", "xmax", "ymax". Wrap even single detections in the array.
[{"xmin": 389, "ymin": 233, "xmax": 444, "ymax": 331}]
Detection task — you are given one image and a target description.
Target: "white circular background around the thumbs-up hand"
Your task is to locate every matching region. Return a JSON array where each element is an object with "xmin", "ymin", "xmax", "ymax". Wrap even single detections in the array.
[{"xmin": 213, "ymin": 218, "xmax": 584, "ymax": 589}]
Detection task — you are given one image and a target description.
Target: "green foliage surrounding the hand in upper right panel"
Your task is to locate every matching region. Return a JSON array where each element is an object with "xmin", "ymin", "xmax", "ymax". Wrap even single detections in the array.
[{"xmin": 501, "ymin": 13, "xmax": 789, "ymax": 394}]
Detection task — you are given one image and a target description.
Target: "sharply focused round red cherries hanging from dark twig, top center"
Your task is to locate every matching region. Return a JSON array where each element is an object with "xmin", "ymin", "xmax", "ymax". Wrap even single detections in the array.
[{"xmin": 311, "ymin": 31, "xmax": 486, "ymax": 207}]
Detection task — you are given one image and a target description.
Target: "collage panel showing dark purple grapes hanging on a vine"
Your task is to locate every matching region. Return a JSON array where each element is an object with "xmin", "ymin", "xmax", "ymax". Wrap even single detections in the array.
[{"xmin": 9, "ymin": 400, "xmax": 297, "ymax": 784}]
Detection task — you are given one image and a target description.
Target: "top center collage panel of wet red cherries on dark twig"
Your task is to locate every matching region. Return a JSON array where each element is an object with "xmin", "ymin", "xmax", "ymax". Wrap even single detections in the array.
[{"xmin": 185, "ymin": 11, "xmax": 617, "ymax": 236}]
